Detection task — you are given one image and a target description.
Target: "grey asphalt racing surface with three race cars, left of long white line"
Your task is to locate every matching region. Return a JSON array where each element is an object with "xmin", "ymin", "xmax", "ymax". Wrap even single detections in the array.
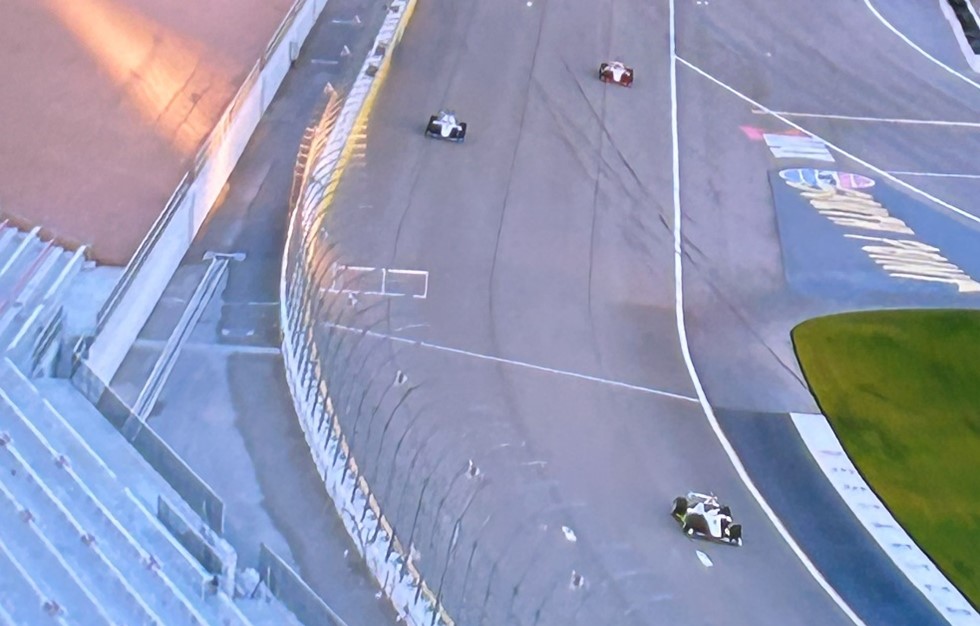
[{"xmin": 312, "ymin": 0, "xmax": 849, "ymax": 625}]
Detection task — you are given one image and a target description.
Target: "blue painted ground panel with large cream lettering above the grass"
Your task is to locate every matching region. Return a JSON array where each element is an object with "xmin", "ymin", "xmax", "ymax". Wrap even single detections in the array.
[{"xmin": 770, "ymin": 168, "xmax": 980, "ymax": 295}]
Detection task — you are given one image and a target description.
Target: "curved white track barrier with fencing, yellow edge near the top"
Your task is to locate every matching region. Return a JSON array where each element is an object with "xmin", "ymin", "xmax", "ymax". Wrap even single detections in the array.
[{"xmin": 280, "ymin": 0, "xmax": 454, "ymax": 626}]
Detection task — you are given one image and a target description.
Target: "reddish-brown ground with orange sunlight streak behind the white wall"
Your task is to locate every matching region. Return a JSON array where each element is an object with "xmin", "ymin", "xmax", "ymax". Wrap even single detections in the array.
[{"xmin": 0, "ymin": 0, "xmax": 292, "ymax": 265}]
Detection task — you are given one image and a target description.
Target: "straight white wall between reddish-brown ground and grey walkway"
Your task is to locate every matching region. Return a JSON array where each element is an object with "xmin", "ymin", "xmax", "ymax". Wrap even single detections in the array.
[{"xmin": 82, "ymin": 0, "xmax": 327, "ymax": 382}]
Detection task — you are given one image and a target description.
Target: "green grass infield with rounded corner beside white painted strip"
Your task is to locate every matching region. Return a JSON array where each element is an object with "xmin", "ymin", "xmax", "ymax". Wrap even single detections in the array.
[{"xmin": 792, "ymin": 310, "xmax": 980, "ymax": 606}]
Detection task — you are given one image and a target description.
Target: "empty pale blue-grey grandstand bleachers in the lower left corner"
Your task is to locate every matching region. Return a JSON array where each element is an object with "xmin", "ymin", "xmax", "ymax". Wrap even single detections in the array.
[{"xmin": 0, "ymin": 222, "xmax": 299, "ymax": 625}]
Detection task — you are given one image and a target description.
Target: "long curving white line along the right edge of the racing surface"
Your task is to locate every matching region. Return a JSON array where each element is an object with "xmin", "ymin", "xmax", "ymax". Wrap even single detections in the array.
[{"xmin": 669, "ymin": 0, "xmax": 864, "ymax": 626}]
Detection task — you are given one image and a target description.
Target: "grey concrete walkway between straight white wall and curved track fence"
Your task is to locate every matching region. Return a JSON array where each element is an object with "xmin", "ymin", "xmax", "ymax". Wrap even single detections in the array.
[{"xmin": 105, "ymin": 0, "xmax": 395, "ymax": 626}]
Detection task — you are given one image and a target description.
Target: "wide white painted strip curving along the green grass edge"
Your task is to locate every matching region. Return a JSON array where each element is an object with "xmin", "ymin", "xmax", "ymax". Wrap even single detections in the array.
[{"xmin": 790, "ymin": 413, "xmax": 980, "ymax": 626}]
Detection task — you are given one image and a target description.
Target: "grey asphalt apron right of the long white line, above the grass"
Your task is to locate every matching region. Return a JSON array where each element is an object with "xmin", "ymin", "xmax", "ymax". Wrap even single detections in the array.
[{"xmin": 679, "ymin": 1, "xmax": 980, "ymax": 412}]
